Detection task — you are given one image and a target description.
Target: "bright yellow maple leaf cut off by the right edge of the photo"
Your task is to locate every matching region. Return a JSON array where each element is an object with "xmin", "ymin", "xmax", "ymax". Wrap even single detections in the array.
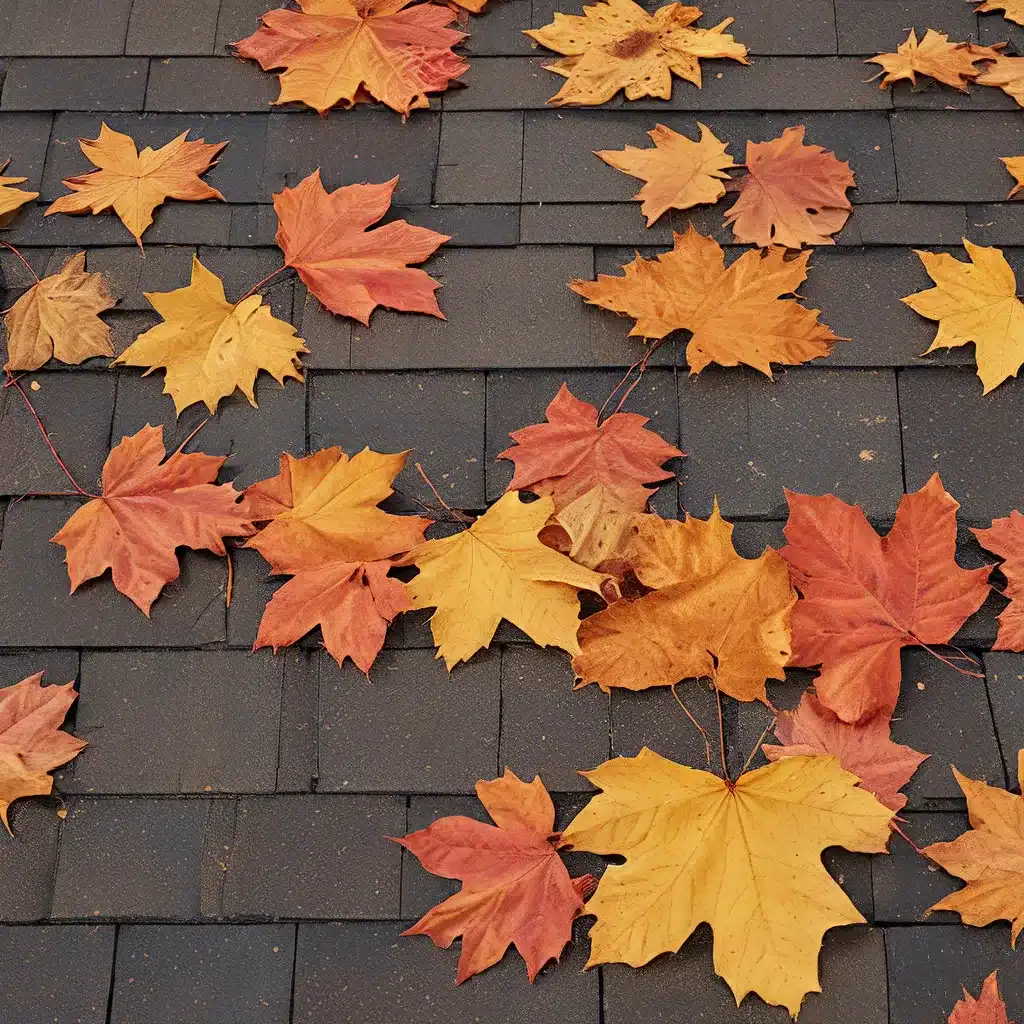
[{"xmin": 903, "ymin": 239, "xmax": 1024, "ymax": 394}]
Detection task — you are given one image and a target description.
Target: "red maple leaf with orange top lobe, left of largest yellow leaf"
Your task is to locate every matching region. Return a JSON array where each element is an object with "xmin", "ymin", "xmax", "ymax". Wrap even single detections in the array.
[{"xmin": 396, "ymin": 768, "xmax": 594, "ymax": 983}]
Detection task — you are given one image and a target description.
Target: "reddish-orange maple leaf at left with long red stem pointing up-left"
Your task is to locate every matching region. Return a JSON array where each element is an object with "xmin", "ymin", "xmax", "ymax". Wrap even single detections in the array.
[{"xmin": 52, "ymin": 424, "xmax": 254, "ymax": 615}]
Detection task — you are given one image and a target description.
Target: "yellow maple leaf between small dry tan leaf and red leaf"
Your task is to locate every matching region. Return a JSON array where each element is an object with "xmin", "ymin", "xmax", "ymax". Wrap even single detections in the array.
[{"xmin": 114, "ymin": 256, "xmax": 309, "ymax": 416}]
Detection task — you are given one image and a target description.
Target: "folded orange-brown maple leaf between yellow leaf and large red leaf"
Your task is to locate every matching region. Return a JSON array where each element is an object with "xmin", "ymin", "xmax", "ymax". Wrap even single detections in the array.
[{"xmin": 572, "ymin": 503, "xmax": 797, "ymax": 700}]
